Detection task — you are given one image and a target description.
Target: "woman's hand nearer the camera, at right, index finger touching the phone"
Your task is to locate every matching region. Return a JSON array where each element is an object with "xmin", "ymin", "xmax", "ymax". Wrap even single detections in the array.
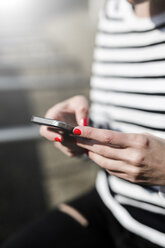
[{"xmin": 73, "ymin": 126, "xmax": 165, "ymax": 185}]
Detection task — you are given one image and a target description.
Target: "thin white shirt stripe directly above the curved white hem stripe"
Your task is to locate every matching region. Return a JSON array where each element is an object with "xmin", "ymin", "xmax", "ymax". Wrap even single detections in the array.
[{"xmin": 115, "ymin": 195, "xmax": 165, "ymax": 215}]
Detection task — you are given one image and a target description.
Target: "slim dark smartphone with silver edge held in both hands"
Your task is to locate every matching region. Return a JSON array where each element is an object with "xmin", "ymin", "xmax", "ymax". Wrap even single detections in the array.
[{"xmin": 31, "ymin": 116, "xmax": 74, "ymax": 134}]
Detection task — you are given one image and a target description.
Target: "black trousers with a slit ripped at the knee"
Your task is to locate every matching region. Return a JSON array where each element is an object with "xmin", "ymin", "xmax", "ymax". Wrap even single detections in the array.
[{"xmin": 1, "ymin": 189, "xmax": 159, "ymax": 248}]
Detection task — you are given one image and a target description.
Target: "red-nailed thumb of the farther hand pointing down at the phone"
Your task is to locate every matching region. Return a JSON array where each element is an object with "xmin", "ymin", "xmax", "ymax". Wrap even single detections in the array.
[{"xmin": 75, "ymin": 97, "xmax": 89, "ymax": 126}]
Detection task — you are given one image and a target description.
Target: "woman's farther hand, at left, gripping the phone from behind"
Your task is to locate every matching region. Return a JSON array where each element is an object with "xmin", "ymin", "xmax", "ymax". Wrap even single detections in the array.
[{"xmin": 40, "ymin": 95, "xmax": 88, "ymax": 157}]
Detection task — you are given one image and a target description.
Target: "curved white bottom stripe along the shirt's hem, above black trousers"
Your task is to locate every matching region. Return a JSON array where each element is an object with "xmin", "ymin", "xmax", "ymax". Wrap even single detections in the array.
[{"xmin": 96, "ymin": 171, "xmax": 165, "ymax": 247}]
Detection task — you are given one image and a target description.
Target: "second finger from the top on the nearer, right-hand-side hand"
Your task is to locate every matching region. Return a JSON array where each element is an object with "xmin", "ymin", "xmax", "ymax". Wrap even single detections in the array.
[{"xmin": 77, "ymin": 139, "xmax": 133, "ymax": 162}]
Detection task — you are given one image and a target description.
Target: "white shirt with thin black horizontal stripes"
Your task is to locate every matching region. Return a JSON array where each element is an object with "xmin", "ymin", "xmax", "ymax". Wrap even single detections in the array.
[{"xmin": 90, "ymin": 0, "xmax": 165, "ymax": 247}]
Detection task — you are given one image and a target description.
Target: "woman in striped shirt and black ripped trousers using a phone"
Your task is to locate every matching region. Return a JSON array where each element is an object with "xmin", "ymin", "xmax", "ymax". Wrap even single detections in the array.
[{"xmin": 4, "ymin": 0, "xmax": 165, "ymax": 248}]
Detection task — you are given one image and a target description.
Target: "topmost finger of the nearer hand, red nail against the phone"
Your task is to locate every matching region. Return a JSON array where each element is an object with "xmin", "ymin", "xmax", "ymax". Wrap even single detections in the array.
[{"xmin": 73, "ymin": 126, "xmax": 140, "ymax": 147}]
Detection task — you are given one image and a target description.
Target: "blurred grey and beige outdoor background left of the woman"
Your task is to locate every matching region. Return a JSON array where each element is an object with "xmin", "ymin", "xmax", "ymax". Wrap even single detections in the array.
[{"xmin": 0, "ymin": 0, "xmax": 103, "ymax": 243}]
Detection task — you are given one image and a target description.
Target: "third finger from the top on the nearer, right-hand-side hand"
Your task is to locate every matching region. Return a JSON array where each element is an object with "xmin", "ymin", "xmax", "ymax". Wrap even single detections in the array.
[{"xmin": 88, "ymin": 151, "xmax": 128, "ymax": 173}]
